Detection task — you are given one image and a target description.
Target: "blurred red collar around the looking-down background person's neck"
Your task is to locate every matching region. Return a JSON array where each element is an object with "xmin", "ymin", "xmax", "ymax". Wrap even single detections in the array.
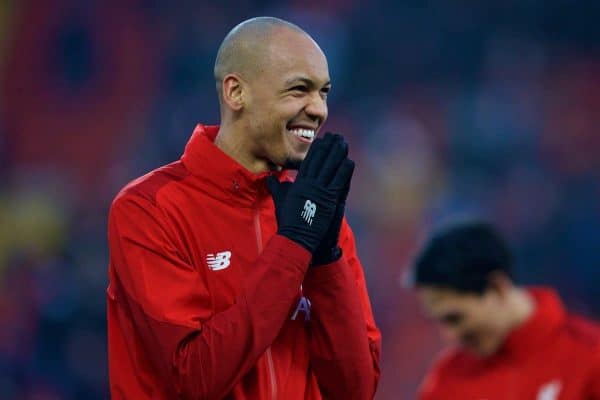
[{"xmin": 502, "ymin": 287, "xmax": 566, "ymax": 358}]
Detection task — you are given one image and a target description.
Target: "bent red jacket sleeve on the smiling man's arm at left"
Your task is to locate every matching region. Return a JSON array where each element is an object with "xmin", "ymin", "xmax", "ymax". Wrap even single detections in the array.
[{"xmin": 108, "ymin": 195, "xmax": 310, "ymax": 399}]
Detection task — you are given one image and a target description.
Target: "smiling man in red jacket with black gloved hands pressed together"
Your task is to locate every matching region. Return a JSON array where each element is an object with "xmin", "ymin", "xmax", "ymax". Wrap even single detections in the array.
[{"xmin": 107, "ymin": 17, "xmax": 380, "ymax": 400}]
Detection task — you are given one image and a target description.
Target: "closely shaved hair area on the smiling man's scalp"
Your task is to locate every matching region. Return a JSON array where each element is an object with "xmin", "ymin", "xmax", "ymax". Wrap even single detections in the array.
[{"xmin": 214, "ymin": 17, "xmax": 309, "ymax": 99}]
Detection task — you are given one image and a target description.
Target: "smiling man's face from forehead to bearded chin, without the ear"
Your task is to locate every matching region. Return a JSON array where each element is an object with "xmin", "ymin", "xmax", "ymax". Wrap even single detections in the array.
[{"xmin": 244, "ymin": 29, "xmax": 330, "ymax": 167}]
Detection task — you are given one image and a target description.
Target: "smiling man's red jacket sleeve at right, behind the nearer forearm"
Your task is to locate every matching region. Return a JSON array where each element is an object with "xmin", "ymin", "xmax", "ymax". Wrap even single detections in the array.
[{"xmin": 304, "ymin": 220, "xmax": 381, "ymax": 399}]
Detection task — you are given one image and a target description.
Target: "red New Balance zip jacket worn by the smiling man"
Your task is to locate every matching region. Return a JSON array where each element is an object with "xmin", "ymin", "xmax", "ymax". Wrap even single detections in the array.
[{"xmin": 107, "ymin": 125, "xmax": 381, "ymax": 400}]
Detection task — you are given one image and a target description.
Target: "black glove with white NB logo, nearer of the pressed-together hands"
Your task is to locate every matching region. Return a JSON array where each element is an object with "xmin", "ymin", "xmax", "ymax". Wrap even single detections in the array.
[{"xmin": 267, "ymin": 133, "xmax": 353, "ymax": 254}]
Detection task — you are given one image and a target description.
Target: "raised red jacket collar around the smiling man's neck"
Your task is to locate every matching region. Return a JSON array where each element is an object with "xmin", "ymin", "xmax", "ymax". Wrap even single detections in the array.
[{"xmin": 181, "ymin": 124, "xmax": 286, "ymax": 206}]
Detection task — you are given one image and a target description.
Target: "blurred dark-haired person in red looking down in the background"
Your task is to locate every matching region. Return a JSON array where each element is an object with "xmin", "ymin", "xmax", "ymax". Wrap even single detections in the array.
[{"xmin": 412, "ymin": 221, "xmax": 600, "ymax": 400}]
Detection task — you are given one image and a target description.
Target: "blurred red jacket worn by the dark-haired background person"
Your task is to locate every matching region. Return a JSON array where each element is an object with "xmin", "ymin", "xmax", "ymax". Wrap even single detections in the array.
[{"xmin": 419, "ymin": 288, "xmax": 600, "ymax": 400}]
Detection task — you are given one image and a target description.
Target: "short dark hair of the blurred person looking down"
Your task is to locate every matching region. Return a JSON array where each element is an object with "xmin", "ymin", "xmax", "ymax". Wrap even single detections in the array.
[{"xmin": 412, "ymin": 220, "xmax": 514, "ymax": 294}]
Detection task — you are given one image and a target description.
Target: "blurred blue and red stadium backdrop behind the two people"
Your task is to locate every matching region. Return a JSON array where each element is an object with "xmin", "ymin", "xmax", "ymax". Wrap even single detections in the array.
[{"xmin": 0, "ymin": 0, "xmax": 600, "ymax": 400}]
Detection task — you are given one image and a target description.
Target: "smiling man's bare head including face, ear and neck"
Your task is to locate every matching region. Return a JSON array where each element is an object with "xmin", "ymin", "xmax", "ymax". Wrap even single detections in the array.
[{"xmin": 216, "ymin": 26, "xmax": 331, "ymax": 172}]
